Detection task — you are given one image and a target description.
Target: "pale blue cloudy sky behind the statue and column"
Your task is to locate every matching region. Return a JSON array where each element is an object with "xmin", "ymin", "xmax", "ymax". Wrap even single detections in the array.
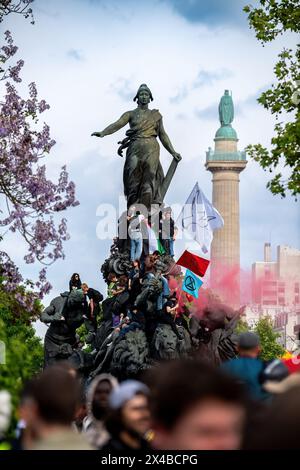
[{"xmin": 1, "ymin": 0, "xmax": 300, "ymax": 338}]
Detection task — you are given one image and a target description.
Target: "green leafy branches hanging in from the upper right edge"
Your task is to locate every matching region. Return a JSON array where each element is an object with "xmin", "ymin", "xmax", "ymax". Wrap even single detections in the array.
[{"xmin": 244, "ymin": 0, "xmax": 300, "ymax": 197}]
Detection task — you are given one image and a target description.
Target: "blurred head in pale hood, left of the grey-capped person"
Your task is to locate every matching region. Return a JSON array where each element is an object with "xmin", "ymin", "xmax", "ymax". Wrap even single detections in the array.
[{"xmin": 86, "ymin": 374, "xmax": 118, "ymax": 420}]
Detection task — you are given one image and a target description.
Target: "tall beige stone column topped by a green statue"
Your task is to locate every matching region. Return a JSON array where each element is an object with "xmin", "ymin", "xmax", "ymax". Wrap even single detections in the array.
[{"xmin": 206, "ymin": 90, "xmax": 247, "ymax": 307}]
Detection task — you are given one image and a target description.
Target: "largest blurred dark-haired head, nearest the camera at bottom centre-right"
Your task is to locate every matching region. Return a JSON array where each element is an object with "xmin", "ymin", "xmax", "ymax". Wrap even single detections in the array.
[{"xmin": 145, "ymin": 360, "xmax": 246, "ymax": 450}]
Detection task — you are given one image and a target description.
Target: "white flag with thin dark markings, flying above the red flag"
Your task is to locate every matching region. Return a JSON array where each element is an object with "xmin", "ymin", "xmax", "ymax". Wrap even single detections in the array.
[{"xmin": 176, "ymin": 183, "xmax": 224, "ymax": 253}]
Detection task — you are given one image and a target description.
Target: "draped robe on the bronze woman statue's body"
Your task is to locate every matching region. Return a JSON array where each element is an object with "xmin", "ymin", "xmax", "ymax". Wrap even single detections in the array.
[{"xmin": 122, "ymin": 108, "xmax": 164, "ymax": 208}]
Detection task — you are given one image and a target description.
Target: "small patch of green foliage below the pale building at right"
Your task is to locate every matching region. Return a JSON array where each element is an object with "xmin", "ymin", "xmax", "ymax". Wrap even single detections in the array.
[{"xmin": 254, "ymin": 317, "xmax": 284, "ymax": 361}]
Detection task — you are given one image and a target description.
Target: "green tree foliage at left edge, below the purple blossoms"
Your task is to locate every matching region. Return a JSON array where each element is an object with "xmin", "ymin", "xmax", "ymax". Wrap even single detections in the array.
[{"xmin": 0, "ymin": 285, "xmax": 43, "ymax": 430}]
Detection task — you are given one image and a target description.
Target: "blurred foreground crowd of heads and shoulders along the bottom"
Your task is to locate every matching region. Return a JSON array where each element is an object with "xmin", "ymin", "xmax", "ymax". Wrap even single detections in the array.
[{"xmin": 0, "ymin": 332, "xmax": 300, "ymax": 452}]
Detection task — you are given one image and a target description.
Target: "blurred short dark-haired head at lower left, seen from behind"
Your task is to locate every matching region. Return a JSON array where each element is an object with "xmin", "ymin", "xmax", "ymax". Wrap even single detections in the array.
[{"xmin": 20, "ymin": 365, "xmax": 81, "ymax": 438}]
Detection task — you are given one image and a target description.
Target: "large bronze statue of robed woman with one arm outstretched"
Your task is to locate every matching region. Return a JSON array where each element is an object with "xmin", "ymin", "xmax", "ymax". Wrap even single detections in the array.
[{"xmin": 92, "ymin": 84, "xmax": 181, "ymax": 209}]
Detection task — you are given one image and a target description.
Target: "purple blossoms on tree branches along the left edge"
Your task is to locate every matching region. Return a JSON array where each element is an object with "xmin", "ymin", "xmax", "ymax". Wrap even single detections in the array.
[{"xmin": 0, "ymin": 31, "xmax": 79, "ymax": 308}]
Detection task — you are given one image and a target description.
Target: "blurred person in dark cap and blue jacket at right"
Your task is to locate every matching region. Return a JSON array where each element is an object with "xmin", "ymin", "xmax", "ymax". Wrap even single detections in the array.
[{"xmin": 221, "ymin": 331, "xmax": 269, "ymax": 400}]
